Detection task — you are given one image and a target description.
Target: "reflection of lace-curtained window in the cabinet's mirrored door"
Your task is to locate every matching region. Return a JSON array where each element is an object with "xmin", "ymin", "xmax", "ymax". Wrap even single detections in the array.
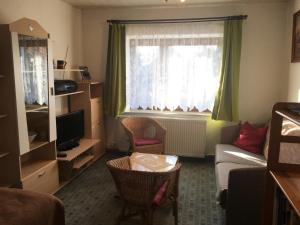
[{"xmin": 19, "ymin": 35, "xmax": 48, "ymax": 105}]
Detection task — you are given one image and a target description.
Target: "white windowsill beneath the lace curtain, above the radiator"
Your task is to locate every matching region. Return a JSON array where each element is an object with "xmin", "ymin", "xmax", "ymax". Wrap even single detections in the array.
[{"xmin": 119, "ymin": 110, "xmax": 211, "ymax": 119}]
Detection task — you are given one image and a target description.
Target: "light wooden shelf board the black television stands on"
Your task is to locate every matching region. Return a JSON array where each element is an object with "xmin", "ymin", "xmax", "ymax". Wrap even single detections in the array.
[{"xmin": 57, "ymin": 138, "xmax": 100, "ymax": 161}]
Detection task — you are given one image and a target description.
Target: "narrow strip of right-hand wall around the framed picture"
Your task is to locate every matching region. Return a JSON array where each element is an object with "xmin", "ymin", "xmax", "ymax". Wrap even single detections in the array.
[{"xmin": 286, "ymin": 0, "xmax": 300, "ymax": 102}]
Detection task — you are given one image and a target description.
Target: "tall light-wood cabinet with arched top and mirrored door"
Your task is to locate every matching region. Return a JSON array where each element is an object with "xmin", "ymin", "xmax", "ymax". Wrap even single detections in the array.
[{"xmin": 0, "ymin": 18, "xmax": 59, "ymax": 193}]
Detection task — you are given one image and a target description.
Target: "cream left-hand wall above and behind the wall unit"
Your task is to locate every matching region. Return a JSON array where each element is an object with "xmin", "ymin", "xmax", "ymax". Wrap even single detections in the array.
[{"xmin": 0, "ymin": 0, "xmax": 82, "ymax": 114}]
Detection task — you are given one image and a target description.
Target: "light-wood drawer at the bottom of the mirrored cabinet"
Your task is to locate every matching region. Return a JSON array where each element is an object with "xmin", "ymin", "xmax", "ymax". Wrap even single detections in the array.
[{"xmin": 22, "ymin": 161, "xmax": 59, "ymax": 193}]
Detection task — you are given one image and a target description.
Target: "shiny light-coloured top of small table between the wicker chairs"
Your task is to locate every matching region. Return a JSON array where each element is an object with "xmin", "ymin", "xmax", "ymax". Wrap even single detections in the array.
[{"xmin": 130, "ymin": 152, "xmax": 178, "ymax": 172}]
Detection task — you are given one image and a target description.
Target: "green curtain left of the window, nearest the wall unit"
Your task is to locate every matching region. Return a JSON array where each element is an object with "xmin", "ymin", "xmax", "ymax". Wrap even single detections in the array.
[{"xmin": 104, "ymin": 24, "xmax": 126, "ymax": 117}]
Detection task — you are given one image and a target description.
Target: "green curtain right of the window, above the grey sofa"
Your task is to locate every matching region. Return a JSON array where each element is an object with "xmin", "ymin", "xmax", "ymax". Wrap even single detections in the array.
[{"xmin": 212, "ymin": 20, "xmax": 243, "ymax": 121}]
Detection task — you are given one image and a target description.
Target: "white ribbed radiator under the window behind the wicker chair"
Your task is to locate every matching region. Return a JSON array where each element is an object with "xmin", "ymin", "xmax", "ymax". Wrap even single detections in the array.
[{"xmin": 154, "ymin": 117, "xmax": 206, "ymax": 157}]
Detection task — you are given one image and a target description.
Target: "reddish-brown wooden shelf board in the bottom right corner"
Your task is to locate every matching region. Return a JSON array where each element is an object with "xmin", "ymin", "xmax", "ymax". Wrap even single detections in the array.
[{"xmin": 270, "ymin": 171, "xmax": 300, "ymax": 217}]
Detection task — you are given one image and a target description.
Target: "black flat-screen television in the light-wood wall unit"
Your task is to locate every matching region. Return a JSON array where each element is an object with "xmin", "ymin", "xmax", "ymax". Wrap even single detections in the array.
[{"xmin": 56, "ymin": 110, "xmax": 84, "ymax": 151}]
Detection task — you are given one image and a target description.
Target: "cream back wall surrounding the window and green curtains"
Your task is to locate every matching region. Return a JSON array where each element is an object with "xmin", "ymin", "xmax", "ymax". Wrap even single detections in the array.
[{"xmin": 82, "ymin": 3, "xmax": 287, "ymax": 154}]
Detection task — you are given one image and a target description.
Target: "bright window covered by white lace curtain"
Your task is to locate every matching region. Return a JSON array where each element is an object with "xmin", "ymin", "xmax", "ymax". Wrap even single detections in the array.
[{"xmin": 126, "ymin": 22, "xmax": 223, "ymax": 112}]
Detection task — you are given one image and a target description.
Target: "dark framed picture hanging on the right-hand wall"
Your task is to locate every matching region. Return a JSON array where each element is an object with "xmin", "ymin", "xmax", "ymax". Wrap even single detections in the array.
[{"xmin": 292, "ymin": 10, "xmax": 300, "ymax": 63}]
